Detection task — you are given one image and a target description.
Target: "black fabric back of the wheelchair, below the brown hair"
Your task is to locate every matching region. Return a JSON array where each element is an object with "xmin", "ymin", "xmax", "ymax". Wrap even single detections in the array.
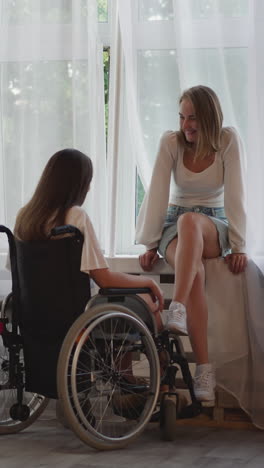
[{"xmin": 3, "ymin": 226, "xmax": 91, "ymax": 398}]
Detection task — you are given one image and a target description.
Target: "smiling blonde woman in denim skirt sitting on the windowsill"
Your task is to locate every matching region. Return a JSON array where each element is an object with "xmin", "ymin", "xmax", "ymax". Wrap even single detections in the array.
[{"xmin": 136, "ymin": 86, "xmax": 247, "ymax": 401}]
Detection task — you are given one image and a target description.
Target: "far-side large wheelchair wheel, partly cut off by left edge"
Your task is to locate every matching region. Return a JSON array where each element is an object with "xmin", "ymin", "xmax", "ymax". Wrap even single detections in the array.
[{"xmin": 0, "ymin": 295, "xmax": 49, "ymax": 434}]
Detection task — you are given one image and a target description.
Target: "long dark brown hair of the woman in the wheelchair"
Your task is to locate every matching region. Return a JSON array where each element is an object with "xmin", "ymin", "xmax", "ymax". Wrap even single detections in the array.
[{"xmin": 14, "ymin": 148, "xmax": 93, "ymax": 241}]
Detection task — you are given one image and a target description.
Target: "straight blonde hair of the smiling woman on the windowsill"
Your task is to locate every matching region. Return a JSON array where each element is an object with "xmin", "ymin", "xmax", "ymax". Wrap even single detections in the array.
[{"xmin": 179, "ymin": 85, "xmax": 223, "ymax": 159}]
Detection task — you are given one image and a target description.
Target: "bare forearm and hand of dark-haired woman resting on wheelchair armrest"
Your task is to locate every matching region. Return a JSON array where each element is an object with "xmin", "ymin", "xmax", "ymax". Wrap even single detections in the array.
[{"xmin": 90, "ymin": 268, "xmax": 164, "ymax": 312}]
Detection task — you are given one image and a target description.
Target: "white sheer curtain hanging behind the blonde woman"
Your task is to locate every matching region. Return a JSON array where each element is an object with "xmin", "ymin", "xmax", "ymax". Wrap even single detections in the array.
[{"xmin": 109, "ymin": 0, "xmax": 264, "ymax": 266}]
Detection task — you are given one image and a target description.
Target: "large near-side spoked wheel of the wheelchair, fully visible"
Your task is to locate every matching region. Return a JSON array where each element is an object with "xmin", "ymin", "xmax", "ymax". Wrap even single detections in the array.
[{"xmin": 57, "ymin": 304, "xmax": 160, "ymax": 450}]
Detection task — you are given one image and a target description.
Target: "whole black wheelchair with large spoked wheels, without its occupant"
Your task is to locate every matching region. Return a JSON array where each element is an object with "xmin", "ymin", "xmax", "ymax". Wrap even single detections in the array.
[{"xmin": 0, "ymin": 226, "xmax": 202, "ymax": 450}]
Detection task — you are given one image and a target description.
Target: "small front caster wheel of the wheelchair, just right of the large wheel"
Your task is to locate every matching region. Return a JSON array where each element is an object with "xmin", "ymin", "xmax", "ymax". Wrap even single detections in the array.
[{"xmin": 160, "ymin": 394, "xmax": 177, "ymax": 441}]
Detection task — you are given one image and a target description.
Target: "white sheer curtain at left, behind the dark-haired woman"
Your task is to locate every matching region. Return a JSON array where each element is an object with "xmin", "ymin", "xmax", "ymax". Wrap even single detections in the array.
[{"xmin": 0, "ymin": 0, "xmax": 106, "ymax": 250}]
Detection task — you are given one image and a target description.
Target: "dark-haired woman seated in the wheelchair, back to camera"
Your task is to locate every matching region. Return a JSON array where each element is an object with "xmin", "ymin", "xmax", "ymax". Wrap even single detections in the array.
[{"xmin": 14, "ymin": 149, "xmax": 163, "ymax": 327}]
